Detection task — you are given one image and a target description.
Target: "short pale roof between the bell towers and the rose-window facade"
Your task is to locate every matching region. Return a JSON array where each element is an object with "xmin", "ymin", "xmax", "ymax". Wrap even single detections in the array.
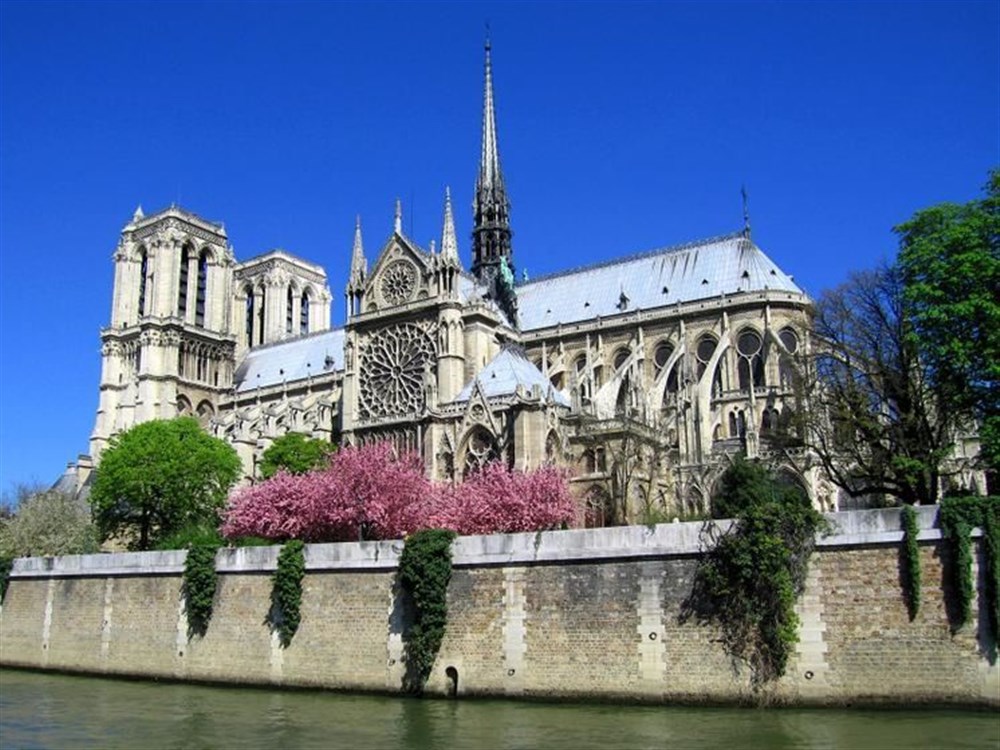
[{"xmin": 235, "ymin": 328, "xmax": 344, "ymax": 393}]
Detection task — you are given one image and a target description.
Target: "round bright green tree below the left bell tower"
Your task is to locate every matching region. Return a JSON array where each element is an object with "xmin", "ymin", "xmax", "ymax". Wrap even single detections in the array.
[{"xmin": 90, "ymin": 417, "xmax": 242, "ymax": 550}]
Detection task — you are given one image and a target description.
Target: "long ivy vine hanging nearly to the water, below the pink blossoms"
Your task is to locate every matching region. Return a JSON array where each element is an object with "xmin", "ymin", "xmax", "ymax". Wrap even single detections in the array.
[{"xmin": 399, "ymin": 529, "xmax": 455, "ymax": 693}]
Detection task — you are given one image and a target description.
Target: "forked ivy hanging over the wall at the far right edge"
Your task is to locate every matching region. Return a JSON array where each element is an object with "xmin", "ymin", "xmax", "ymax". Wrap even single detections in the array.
[{"xmin": 938, "ymin": 497, "xmax": 1000, "ymax": 635}]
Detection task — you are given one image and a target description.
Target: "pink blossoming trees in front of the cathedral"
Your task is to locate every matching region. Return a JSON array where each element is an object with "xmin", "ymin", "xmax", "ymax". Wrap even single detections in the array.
[{"xmin": 222, "ymin": 443, "xmax": 579, "ymax": 542}]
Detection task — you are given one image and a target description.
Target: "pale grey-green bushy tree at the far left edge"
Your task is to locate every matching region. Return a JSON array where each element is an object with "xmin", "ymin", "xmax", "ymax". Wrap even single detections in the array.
[{"xmin": 0, "ymin": 490, "xmax": 100, "ymax": 557}]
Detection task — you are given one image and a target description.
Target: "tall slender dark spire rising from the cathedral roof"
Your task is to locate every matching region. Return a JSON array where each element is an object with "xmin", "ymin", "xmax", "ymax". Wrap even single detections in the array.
[{"xmin": 471, "ymin": 31, "xmax": 517, "ymax": 324}]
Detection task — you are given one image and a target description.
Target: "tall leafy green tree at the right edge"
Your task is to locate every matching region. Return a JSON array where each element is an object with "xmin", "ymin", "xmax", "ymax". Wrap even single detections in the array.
[{"xmin": 896, "ymin": 169, "xmax": 1000, "ymax": 482}]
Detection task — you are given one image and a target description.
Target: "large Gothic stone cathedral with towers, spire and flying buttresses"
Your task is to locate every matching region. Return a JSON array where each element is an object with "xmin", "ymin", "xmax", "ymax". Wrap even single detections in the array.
[{"xmin": 86, "ymin": 43, "xmax": 824, "ymax": 525}]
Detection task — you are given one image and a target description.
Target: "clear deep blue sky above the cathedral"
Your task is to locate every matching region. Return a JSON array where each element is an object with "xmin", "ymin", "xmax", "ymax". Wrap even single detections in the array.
[{"xmin": 0, "ymin": 0, "xmax": 1000, "ymax": 489}]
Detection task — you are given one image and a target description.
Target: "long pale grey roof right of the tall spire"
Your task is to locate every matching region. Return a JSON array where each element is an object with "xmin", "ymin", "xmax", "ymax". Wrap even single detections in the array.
[{"xmin": 517, "ymin": 233, "xmax": 804, "ymax": 331}]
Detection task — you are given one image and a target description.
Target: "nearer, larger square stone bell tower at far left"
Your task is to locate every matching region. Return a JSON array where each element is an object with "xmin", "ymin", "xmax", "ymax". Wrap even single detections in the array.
[{"xmin": 90, "ymin": 206, "xmax": 235, "ymax": 460}]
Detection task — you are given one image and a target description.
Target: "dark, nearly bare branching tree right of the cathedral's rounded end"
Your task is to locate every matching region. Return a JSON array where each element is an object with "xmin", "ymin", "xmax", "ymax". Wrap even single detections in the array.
[{"xmin": 802, "ymin": 267, "xmax": 956, "ymax": 504}]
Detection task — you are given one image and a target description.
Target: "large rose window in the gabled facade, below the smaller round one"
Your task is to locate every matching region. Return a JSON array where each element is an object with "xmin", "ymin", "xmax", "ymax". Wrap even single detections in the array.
[{"xmin": 360, "ymin": 324, "xmax": 434, "ymax": 418}]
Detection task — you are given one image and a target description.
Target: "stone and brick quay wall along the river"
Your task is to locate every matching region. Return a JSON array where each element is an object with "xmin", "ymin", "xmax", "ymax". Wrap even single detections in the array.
[{"xmin": 0, "ymin": 507, "xmax": 1000, "ymax": 707}]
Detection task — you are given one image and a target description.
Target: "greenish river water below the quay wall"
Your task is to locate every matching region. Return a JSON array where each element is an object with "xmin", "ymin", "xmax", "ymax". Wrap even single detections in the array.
[{"xmin": 0, "ymin": 669, "xmax": 1000, "ymax": 750}]
